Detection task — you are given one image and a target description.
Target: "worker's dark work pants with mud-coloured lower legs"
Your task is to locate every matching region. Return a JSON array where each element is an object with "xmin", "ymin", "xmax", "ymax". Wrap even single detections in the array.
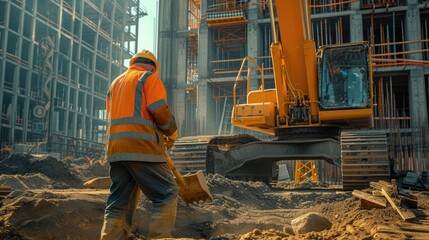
[{"xmin": 101, "ymin": 161, "xmax": 178, "ymax": 240}]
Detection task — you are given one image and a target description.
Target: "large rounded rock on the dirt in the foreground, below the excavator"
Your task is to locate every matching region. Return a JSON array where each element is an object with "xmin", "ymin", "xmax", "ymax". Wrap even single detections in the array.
[{"xmin": 291, "ymin": 212, "xmax": 332, "ymax": 234}]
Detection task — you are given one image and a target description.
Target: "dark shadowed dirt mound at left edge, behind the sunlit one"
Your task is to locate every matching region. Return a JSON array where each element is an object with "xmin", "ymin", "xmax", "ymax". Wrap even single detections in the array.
[{"xmin": 0, "ymin": 154, "xmax": 82, "ymax": 188}]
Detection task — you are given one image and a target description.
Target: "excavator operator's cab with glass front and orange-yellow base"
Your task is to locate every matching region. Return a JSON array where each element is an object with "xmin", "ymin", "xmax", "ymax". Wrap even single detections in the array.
[{"xmin": 317, "ymin": 43, "xmax": 373, "ymax": 127}]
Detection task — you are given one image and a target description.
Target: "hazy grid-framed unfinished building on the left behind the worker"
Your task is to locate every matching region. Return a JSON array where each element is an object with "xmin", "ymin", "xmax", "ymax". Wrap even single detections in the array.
[{"xmin": 0, "ymin": 0, "xmax": 146, "ymax": 157}]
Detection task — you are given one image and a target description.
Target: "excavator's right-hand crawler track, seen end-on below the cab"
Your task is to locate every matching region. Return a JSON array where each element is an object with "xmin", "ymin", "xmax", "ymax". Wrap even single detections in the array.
[{"xmin": 341, "ymin": 130, "xmax": 390, "ymax": 190}]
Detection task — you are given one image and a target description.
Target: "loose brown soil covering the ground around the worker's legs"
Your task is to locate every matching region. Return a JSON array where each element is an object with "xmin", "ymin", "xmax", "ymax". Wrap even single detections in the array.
[{"xmin": 0, "ymin": 155, "xmax": 429, "ymax": 240}]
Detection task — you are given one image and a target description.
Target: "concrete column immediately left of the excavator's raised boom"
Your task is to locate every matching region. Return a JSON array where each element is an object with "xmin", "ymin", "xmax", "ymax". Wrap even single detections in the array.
[{"xmin": 247, "ymin": 0, "xmax": 263, "ymax": 90}]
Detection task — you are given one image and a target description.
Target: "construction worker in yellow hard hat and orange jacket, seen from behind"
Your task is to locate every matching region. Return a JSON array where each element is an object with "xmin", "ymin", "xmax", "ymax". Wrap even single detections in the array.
[{"xmin": 101, "ymin": 50, "xmax": 178, "ymax": 240}]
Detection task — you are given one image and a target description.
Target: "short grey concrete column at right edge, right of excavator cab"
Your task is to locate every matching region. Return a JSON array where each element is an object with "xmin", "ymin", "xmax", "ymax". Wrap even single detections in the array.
[{"xmin": 408, "ymin": 67, "xmax": 428, "ymax": 128}]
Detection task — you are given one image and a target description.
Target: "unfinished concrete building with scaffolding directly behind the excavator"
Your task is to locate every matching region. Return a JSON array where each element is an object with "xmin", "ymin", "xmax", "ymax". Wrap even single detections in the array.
[{"xmin": 158, "ymin": 0, "xmax": 429, "ymax": 180}]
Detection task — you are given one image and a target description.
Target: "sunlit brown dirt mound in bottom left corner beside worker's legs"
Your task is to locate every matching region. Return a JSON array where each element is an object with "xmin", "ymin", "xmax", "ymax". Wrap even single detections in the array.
[{"xmin": 0, "ymin": 191, "xmax": 106, "ymax": 239}]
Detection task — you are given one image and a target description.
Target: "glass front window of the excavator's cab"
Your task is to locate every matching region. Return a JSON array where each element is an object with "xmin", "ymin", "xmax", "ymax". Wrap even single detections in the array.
[{"xmin": 319, "ymin": 44, "xmax": 371, "ymax": 110}]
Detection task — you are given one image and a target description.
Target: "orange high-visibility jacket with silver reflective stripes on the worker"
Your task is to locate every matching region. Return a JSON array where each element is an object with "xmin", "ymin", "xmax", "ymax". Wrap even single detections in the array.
[{"xmin": 106, "ymin": 65, "xmax": 177, "ymax": 162}]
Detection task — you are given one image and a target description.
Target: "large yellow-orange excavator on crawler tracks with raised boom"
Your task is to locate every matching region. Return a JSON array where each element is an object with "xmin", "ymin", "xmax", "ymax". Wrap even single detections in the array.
[{"xmin": 172, "ymin": 0, "xmax": 390, "ymax": 190}]
